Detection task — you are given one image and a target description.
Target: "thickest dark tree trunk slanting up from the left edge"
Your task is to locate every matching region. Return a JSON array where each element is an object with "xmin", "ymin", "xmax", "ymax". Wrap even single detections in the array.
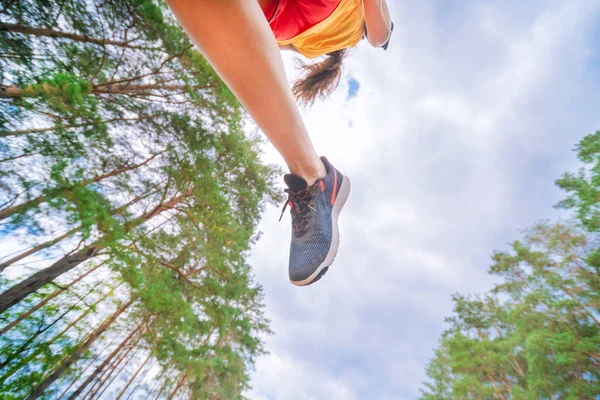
[{"xmin": 0, "ymin": 189, "xmax": 192, "ymax": 314}]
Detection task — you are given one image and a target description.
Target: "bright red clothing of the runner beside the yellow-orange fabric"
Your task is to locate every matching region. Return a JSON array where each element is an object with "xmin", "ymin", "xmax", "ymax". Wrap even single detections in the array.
[{"xmin": 263, "ymin": 0, "xmax": 341, "ymax": 40}]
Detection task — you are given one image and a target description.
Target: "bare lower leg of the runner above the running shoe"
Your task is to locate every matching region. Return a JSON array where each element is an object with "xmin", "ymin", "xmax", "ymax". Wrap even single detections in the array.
[{"xmin": 167, "ymin": 0, "xmax": 325, "ymax": 185}]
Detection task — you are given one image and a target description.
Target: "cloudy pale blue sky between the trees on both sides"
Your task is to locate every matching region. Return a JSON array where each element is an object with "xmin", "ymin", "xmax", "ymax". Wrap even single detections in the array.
[{"xmin": 248, "ymin": 0, "xmax": 600, "ymax": 400}]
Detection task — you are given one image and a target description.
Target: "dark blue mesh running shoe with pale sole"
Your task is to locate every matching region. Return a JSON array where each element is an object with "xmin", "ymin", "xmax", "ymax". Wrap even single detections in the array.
[{"xmin": 281, "ymin": 157, "xmax": 350, "ymax": 286}]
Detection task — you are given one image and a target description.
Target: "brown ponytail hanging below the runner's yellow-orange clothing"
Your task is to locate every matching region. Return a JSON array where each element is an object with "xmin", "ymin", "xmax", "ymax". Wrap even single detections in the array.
[{"xmin": 292, "ymin": 49, "xmax": 348, "ymax": 106}]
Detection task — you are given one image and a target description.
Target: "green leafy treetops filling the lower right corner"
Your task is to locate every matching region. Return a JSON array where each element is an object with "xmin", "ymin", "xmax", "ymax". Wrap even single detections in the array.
[{"xmin": 421, "ymin": 132, "xmax": 600, "ymax": 400}]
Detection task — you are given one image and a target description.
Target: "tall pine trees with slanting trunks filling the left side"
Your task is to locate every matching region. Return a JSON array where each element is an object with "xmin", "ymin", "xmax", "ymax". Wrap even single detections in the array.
[{"xmin": 0, "ymin": 0, "xmax": 279, "ymax": 399}]
